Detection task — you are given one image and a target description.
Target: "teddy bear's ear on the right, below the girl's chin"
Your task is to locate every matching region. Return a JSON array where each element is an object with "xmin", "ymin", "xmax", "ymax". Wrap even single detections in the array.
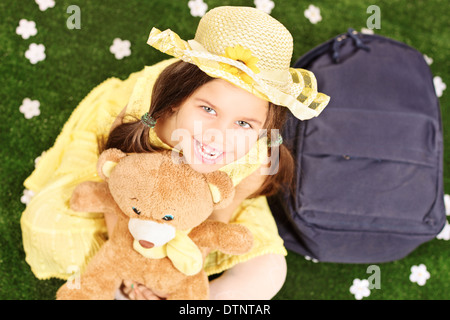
[{"xmin": 204, "ymin": 171, "xmax": 234, "ymax": 209}]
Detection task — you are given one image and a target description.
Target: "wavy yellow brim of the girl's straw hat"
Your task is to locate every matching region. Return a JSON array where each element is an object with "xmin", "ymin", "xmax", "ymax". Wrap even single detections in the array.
[{"xmin": 147, "ymin": 28, "xmax": 330, "ymax": 120}]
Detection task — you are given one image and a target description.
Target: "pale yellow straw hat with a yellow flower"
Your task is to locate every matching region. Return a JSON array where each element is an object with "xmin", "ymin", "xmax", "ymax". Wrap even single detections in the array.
[{"xmin": 147, "ymin": 6, "xmax": 330, "ymax": 120}]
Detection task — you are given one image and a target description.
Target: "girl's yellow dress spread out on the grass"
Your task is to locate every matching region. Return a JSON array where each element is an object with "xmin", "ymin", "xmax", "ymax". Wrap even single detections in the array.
[{"xmin": 20, "ymin": 59, "xmax": 287, "ymax": 279}]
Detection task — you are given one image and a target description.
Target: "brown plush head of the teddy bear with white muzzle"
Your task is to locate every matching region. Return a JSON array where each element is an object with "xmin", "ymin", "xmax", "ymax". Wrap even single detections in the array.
[{"xmin": 97, "ymin": 149, "xmax": 234, "ymax": 248}]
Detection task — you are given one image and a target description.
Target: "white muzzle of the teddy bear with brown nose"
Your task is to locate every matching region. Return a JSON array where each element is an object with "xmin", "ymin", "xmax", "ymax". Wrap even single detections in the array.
[{"xmin": 128, "ymin": 218, "xmax": 175, "ymax": 249}]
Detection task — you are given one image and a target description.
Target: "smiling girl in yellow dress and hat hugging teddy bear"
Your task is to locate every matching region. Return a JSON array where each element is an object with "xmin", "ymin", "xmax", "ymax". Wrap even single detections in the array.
[{"xmin": 21, "ymin": 7, "xmax": 329, "ymax": 299}]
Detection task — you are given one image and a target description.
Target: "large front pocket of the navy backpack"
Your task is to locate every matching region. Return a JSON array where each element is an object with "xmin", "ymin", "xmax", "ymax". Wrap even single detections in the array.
[{"xmin": 296, "ymin": 108, "xmax": 440, "ymax": 234}]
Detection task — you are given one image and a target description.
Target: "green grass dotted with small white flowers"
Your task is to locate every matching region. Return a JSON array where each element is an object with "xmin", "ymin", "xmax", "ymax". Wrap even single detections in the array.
[{"xmin": 0, "ymin": 0, "xmax": 450, "ymax": 300}]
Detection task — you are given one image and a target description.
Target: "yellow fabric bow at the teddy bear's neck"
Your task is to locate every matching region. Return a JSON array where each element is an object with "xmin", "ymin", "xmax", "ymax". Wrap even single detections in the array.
[{"xmin": 133, "ymin": 230, "xmax": 203, "ymax": 276}]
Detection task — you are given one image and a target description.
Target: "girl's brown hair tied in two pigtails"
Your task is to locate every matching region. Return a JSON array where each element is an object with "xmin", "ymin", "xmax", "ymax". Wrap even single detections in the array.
[{"xmin": 103, "ymin": 61, "xmax": 294, "ymax": 197}]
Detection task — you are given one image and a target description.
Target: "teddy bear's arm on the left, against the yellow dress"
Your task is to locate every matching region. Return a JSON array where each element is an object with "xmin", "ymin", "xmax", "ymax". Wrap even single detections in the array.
[{"xmin": 70, "ymin": 181, "xmax": 120, "ymax": 212}]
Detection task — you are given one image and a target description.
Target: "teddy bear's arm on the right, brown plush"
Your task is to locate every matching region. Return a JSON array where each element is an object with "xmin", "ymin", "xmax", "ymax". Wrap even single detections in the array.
[{"xmin": 189, "ymin": 220, "xmax": 253, "ymax": 254}]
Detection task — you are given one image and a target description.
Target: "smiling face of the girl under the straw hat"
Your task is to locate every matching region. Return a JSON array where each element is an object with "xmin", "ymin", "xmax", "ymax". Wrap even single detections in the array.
[{"xmin": 164, "ymin": 79, "xmax": 269, "ymax": 173}]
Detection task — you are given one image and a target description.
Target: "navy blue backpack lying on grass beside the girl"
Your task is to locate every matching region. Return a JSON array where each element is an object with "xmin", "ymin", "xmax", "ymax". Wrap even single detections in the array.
[{"xmin": 268, "ymin": 29, "xmax": 446, "ymax": 263}]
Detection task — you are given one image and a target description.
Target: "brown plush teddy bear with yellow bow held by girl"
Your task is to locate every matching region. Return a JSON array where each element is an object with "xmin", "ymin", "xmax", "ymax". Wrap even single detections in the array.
[{"xmin": 56, "ymin": 149, "xmax": 253, "ymax": 300}]
